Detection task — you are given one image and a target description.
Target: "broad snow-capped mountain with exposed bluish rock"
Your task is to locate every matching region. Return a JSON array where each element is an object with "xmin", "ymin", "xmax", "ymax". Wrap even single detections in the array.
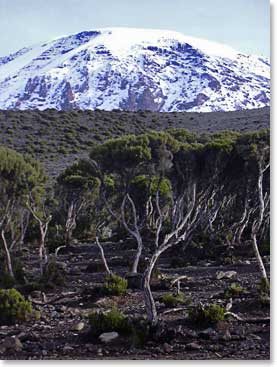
[{"xmin": 0, "ymin": 28, "xmax": 270, "ymax": 112}]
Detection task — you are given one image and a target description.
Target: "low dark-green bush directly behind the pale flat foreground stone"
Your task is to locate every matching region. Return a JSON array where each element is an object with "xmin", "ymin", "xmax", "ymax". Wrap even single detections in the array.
[{"xmin": 89, "ymin": 307, "xmax": 131, "ymax": 337}]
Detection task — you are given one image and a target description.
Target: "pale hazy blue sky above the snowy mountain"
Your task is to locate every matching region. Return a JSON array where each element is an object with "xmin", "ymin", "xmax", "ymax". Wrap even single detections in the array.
[{"xmin": 0, "ymin": 0, "xmax": 270, "ymax": 57}]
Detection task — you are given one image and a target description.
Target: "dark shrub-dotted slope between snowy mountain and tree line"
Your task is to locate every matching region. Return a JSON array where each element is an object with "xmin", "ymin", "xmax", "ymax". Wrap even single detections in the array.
[{"xmin": 0, "ymin": 107, "xmax": 270, "ymax": 176}]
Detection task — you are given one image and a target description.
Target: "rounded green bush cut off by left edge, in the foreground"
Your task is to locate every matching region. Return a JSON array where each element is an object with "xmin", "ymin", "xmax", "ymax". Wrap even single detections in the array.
[{"xmin": 0, "ymin": 288, "xmax": 32, "ymax": 325}]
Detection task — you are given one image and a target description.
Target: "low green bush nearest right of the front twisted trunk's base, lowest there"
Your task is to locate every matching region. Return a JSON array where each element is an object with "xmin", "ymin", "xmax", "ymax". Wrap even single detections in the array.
[{"xmin": 189, "ymin": 304, "xmax": 225, "ymax": 325}]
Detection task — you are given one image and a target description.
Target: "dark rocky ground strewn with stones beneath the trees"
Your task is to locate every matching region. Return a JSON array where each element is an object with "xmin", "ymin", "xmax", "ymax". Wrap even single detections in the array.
[{"xmin": 0, "ymin": 243, "xmax": 270, "ymax": 360}]
